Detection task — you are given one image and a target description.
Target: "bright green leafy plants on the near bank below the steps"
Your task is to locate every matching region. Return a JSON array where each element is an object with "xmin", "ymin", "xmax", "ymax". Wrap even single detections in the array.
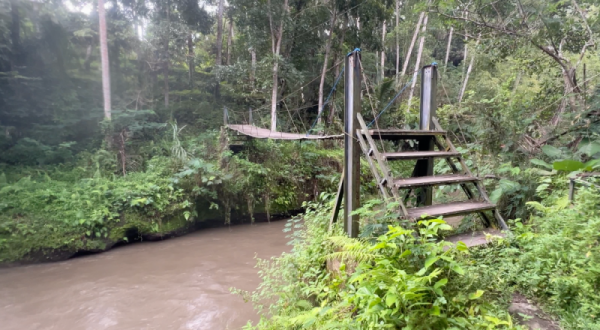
[{"xmin": 243, "ymin": 175, "xmax": 600, "ymax": 329}]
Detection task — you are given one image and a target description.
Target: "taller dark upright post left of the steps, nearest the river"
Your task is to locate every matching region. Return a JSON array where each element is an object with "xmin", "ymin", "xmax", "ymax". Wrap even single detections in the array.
[{"xmin": 344, "ymin": 50, "xmax": 361, "ymax": 237}]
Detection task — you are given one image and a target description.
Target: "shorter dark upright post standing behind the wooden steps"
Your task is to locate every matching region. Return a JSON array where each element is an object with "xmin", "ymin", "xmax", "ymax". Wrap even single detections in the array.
[{"xmin": 414, "ymin": 65, "xmax": 437, "ymax": 205}]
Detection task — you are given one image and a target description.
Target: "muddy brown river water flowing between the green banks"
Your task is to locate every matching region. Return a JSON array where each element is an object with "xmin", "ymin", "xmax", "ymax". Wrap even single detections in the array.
[{"xmin": 0, "ymin": 221, "xmax": 290, "ymax": 330}]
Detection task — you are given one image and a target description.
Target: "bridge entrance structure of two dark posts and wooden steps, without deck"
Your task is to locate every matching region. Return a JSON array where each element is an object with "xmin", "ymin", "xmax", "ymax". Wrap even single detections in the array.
[{"xmin": 331, "ymin": 56, "xmax": 508, "ymax": 237}]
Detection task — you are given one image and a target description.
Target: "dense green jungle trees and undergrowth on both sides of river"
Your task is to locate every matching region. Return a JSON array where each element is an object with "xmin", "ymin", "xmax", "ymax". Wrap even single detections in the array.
[{"xmin": 0, "ymin": 0, "xmax": 600, "ymax": 329}]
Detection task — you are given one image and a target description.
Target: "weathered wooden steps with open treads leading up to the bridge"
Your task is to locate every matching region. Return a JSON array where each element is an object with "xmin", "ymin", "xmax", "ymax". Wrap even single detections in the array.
[{"xmin": 356, "ymin": 114, "xmax": 508, "ymax": 230}]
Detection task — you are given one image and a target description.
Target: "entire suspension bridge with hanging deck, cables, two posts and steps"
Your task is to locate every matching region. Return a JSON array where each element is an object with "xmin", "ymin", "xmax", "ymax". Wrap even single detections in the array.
[{"xmin": 225, "ymin": 49, "xmax": 508, "ymax": 246}]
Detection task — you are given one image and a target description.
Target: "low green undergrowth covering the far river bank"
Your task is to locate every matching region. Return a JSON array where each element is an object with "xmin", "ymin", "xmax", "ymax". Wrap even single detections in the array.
[{"xmin": 0, "ymin": 132, "xmax": 340, "ymax": 262}]
